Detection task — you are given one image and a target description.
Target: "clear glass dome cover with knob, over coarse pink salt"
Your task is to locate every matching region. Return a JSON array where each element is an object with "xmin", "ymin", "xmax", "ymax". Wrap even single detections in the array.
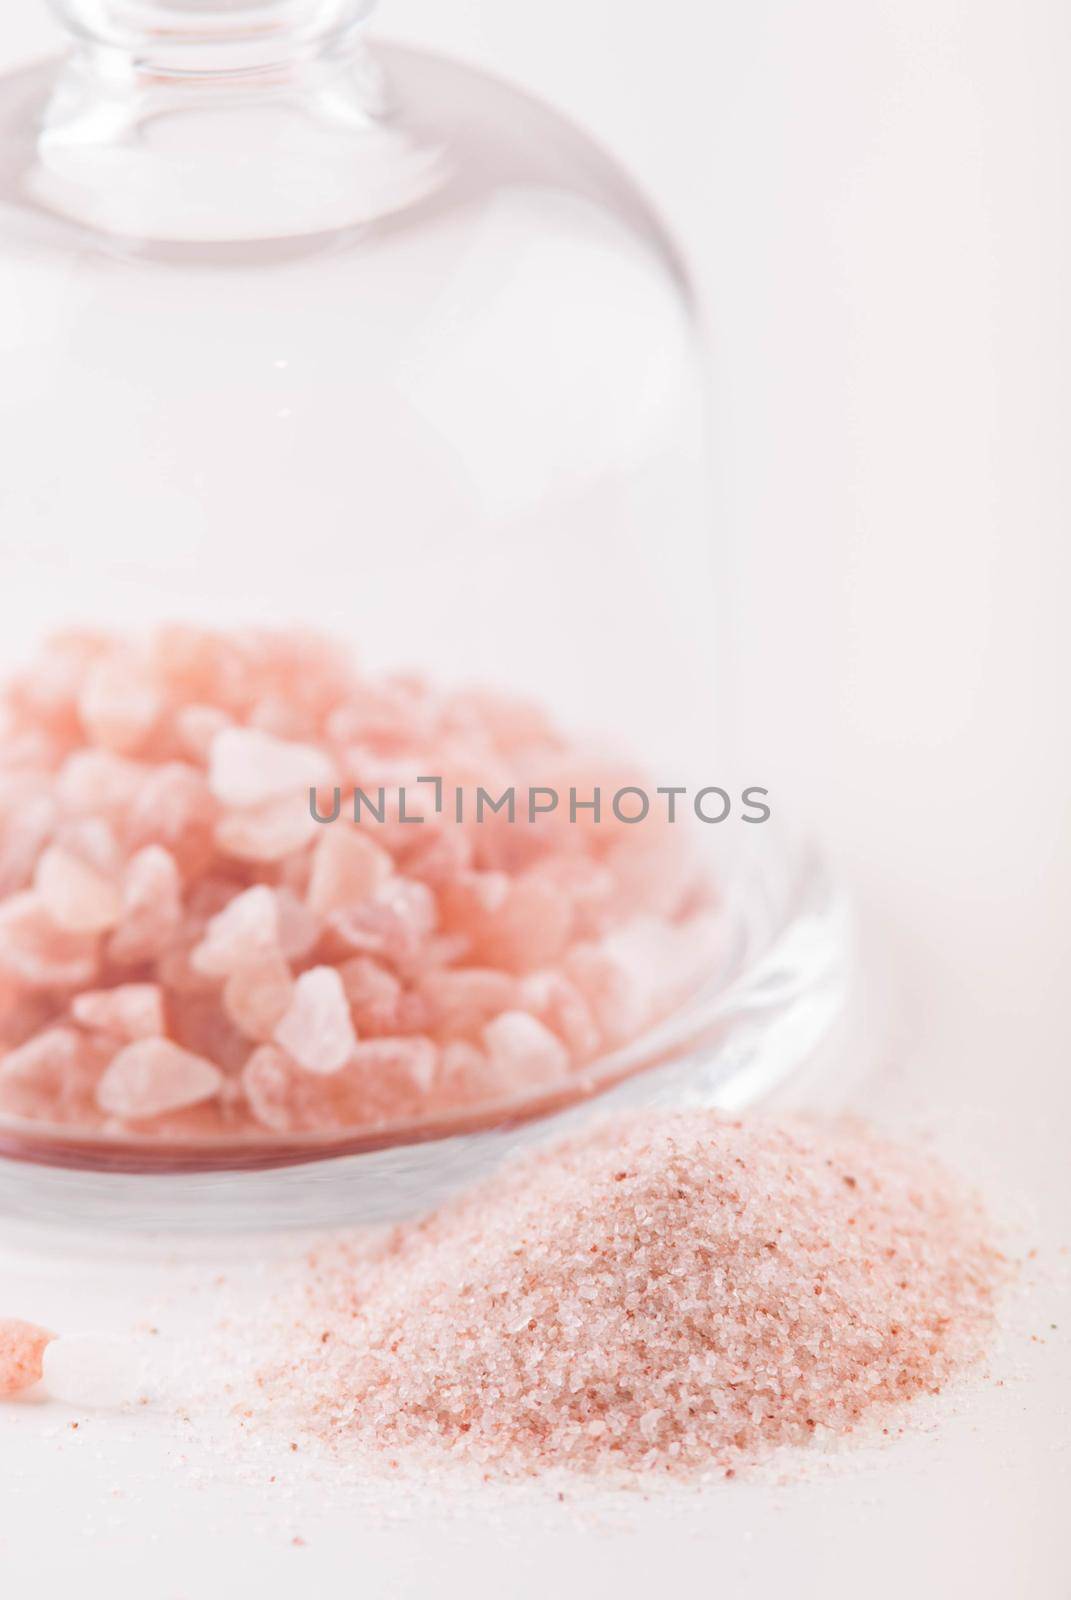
[{"xmin": 0, "ymin": 0, "xmax": 834, "ymax": 1209}]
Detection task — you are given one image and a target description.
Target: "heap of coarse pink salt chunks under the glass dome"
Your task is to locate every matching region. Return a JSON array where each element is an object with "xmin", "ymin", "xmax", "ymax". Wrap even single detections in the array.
[{"xmin": 0, "ymin": 626, "xmax": 719, "ymax": 1141}]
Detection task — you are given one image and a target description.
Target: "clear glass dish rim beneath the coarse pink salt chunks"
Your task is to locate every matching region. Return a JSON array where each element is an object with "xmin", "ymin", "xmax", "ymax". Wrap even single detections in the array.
[{"xmin": 0, "ymin": 851, "xmax": 852, "ymax": 1232}]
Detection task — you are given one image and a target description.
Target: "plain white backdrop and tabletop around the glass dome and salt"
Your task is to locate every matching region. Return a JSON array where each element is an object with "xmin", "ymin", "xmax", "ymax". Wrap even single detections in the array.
[{"xmin": 0, "ymin": 0, "xmax": 1071, "ymax": 1600}]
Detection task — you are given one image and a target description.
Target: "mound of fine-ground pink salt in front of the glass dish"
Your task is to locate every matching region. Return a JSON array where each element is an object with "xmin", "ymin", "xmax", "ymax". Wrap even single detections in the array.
[{"xmin": 264, "ymin": 1112, "xmax": 1002, "ymax": 1474}]
